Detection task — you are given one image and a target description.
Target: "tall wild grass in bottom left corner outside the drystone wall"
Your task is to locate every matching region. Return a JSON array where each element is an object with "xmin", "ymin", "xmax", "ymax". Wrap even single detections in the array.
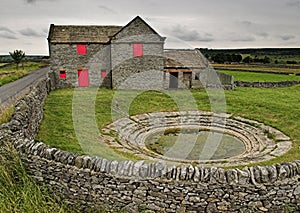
[{"xmin": 0, "ymin": 144, "xmax": 76, "ymax": 213}]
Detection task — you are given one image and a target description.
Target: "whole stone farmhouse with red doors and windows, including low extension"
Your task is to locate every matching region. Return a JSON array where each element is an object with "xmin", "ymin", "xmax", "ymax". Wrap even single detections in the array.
[{"xmin": 48, "ymin": 16, "xmax": 230, "ymax": 89}]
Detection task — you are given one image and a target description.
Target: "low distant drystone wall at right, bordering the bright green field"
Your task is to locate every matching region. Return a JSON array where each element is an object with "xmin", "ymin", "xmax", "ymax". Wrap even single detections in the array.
[{"xmin": 234, "ymin": 81, "xmax": 300, "ymax": 88}]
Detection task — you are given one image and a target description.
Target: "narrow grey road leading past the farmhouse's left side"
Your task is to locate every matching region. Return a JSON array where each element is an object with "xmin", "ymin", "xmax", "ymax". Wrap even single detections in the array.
[{"xmin": 0, "ymin": 67, "xmax": 49, "ymax": 106}]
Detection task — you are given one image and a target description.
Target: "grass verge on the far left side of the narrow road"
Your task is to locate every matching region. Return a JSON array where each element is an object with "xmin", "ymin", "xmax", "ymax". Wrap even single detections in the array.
[{"xmin": 0, "ymin": 62, "xmax": 47, "ymax": 86}]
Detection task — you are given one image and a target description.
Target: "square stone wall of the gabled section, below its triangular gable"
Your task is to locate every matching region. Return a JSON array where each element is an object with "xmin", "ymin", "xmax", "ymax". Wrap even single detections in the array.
[{"xmin": 111, "ymin": 35, "xmax": 165, "ymax": 89}]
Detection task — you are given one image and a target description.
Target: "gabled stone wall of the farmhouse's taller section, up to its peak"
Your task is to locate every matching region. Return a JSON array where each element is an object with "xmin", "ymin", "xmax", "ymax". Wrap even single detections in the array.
[{"xmin": 111, "ymin": 18, "xmax": 164, "ymax": 89}]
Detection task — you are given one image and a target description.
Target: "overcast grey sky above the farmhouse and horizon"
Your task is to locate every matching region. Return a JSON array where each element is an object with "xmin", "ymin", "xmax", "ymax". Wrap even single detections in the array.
[{"xmin": 0, "ymin": 0, "xmax": 300, "ymax": 55}]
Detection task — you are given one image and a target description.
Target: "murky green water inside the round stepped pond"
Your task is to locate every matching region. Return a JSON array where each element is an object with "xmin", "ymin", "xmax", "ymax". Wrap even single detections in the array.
[{"xmin": 145, "ymin": 129, "xmax": 245, "ymax": 160}]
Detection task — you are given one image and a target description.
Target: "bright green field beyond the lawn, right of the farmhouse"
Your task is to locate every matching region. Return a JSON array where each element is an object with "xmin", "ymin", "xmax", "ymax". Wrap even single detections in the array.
[{"xmin": 218, "ymin": 70, "xmax": 300, "ymax": 82}]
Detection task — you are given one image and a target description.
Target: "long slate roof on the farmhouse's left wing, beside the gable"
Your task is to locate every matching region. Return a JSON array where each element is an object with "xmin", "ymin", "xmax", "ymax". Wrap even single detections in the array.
[{"xmin": 48, "ymin": 24, "xmax": 122, "ymax": 43}]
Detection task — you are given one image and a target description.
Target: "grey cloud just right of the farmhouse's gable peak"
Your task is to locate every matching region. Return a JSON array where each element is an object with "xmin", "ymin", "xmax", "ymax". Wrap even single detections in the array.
[{"xmin": 169, "ymin": 25, "xmax": 214, "ymax": 42}]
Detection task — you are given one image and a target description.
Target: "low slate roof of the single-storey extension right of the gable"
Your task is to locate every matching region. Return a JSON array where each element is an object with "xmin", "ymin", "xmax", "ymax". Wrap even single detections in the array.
[{"xmin": 164, "ymin": 49, "xmax": 208, "ymax": 69}]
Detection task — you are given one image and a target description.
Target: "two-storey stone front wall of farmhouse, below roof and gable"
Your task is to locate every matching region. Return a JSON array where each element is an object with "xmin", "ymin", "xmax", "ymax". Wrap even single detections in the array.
[{"xmin": 50, "ymin": 42, "xmax": 164, "ymax": 89}]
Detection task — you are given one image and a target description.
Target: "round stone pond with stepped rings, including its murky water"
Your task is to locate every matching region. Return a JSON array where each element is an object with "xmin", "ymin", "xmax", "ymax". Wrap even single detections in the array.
[{"xmin": 101, "ymin": 111, "xmax": 292, "ymax": 166}]
